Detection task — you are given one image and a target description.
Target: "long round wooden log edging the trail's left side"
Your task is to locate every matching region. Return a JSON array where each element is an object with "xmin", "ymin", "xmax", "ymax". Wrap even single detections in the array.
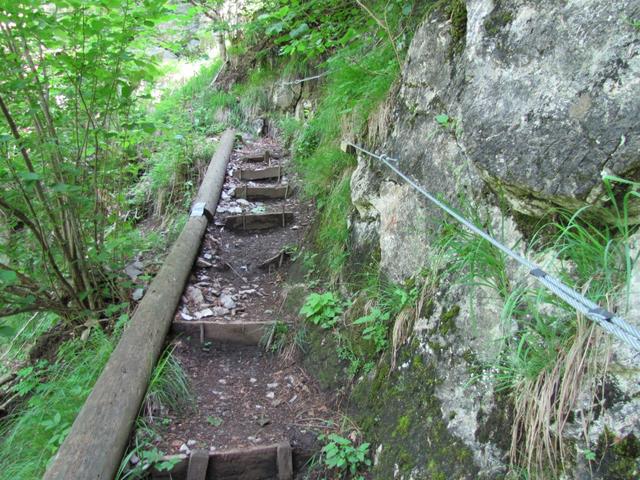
[{"xmin": 43, "ymin": 130, "xmax": 235, "ymax": 480}]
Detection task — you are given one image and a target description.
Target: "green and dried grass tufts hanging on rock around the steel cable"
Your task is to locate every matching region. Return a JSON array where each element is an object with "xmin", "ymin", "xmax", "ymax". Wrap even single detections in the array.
[{"xmin": 440, "ymin": 177, "xmax": 640, "ymax": 478}]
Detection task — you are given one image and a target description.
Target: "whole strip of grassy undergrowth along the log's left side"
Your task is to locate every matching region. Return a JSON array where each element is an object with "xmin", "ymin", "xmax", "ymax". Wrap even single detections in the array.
[{"xmin": 0, "ymin": 57, "xmax": 234, "ymax": 480}]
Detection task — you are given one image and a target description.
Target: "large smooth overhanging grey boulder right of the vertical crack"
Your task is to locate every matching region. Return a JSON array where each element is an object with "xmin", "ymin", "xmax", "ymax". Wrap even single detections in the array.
[{"xmin": 459, "ymin": 0, "xmax": 640, "ymax": 218}]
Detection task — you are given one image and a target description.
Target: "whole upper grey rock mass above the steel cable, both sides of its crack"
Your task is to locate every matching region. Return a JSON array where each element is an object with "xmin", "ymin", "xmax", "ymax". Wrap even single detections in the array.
[{"xmin": 352, "ymin": 0, "xmax": 640, "ymax": 236}]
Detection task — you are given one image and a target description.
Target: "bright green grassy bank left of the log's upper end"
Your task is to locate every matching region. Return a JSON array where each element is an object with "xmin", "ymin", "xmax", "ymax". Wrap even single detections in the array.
[{"xmin": 131, "ymin": 62, "xmax": 239, "ymax": 218}]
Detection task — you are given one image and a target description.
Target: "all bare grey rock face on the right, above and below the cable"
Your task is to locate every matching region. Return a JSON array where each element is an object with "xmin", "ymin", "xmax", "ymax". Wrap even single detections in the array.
[{"xmin": 351, "ymin": 0, "xmax": 640, "ymax": 479}]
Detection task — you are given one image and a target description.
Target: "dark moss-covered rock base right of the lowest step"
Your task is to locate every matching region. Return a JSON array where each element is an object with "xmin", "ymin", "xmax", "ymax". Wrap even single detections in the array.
[{"xmin": 349, "ymin": 348, "xmax": 477, "ymax": 479}]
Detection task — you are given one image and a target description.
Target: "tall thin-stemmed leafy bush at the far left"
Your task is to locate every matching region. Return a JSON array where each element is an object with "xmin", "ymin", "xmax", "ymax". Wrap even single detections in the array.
[{"xmin": 0, "ymin": 0, "xmax": 166, "ymax": 321}]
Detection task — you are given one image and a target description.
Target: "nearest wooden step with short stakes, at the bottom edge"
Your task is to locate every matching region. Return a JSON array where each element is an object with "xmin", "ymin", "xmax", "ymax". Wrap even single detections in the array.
[{"xmin": 151, "ymin": 442, "xmax": 293, "ymax": 480}]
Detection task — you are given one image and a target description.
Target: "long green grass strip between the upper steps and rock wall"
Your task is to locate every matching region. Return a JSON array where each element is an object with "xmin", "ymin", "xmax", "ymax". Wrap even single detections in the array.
[{"xmin": 281, "ymin": 43, "xmax": 399, "ymax": 280}]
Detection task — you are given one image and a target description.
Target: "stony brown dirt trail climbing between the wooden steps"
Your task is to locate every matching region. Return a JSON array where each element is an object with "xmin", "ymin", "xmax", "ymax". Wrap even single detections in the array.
[{"xmin": 153, "ymin": 131, "xmax": 334, "ymax": 472}]
